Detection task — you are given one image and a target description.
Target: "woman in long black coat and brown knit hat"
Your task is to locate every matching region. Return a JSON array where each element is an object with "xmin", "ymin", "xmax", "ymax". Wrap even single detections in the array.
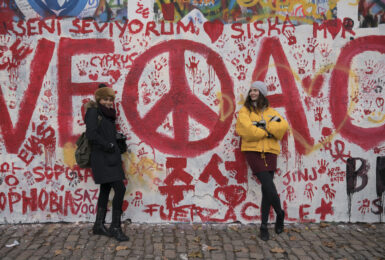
[{"xmin": 85, "ymin": 84, "xmax": 128, "ymax": 241}]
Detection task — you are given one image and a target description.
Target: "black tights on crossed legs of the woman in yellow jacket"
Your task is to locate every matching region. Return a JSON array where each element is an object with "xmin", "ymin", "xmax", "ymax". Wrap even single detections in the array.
[{"xmin": 255, "ymin": 171, "xmax": 282, "ymax": 224}]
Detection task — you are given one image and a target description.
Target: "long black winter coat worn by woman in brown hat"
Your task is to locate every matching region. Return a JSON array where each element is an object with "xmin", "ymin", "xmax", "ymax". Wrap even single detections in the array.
[{"xmin": 85, "ymin": 101, "xmax": 125, "ymax": 184}]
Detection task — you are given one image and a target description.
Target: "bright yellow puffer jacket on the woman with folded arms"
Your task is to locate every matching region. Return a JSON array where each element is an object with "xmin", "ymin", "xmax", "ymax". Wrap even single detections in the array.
[{"xmin": 235, "ymin": 106, "xmax": 289, "ymax": 154}]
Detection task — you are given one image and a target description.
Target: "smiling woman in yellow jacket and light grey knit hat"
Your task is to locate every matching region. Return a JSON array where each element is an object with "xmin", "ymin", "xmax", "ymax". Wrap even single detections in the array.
[{"xmin": 236, "ymin": 81, "xmax": 288, "ymax": 241}]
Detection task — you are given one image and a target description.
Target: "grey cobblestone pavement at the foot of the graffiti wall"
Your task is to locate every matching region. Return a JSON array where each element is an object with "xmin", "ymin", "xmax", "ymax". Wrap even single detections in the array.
[{"xmin": 0, "ymin": 222, "xmax": 385, "ymax": 260}]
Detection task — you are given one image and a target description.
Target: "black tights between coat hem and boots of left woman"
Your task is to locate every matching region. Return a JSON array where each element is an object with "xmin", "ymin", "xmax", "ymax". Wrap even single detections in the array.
[{"xmin": 98, "ymin": 181, "xmax": 126, "ymax": 211}]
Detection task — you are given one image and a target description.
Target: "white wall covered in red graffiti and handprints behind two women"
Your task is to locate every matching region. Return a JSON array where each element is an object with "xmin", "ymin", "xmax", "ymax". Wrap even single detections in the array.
[{"xmin": 0, "ymin": 0, "xmax": 385, "ymax": 223}]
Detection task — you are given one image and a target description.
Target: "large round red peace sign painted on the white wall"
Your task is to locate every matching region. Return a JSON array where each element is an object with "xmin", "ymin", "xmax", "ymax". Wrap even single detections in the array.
[{"xmin": 122, "ymin": 40, "xmax": 235, "ymax": 156}]
